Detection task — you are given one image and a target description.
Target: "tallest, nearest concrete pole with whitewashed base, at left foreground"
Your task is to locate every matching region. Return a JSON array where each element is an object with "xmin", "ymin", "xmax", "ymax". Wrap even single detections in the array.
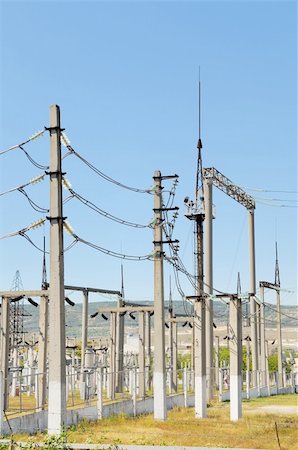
[{"xmin": 48, "ymin": 105, "xmax": 66, "ymax": 434}]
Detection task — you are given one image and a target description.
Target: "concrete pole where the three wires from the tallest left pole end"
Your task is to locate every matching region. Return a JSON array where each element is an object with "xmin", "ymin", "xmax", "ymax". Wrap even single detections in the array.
[{"xmin": 153, "ymin": 170, "xmax": 167, "ymax": 420}]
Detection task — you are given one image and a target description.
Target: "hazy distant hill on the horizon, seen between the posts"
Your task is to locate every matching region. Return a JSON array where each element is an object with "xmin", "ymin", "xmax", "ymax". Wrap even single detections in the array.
[{"xmin": 24, "ymin": 301, "xmax": 298, "ymax": 338}]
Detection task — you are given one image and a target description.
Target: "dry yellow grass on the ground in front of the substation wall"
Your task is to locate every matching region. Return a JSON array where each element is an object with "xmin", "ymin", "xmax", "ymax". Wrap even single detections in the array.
[{"xmin": 7, "ymin": 394, "xmax": 298, "ymax": 450}]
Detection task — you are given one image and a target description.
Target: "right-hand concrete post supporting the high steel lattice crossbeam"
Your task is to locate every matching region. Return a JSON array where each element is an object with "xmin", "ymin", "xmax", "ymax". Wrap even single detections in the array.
[{"xmin": 248, "ymin": 209, "xmax": 259, "ymax": 387}]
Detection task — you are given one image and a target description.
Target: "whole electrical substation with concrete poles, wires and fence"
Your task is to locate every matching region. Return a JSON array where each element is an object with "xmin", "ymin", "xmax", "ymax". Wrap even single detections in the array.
[{"xmin": 0, "ymin": 105, "xmax": 294, "ymax": 435}]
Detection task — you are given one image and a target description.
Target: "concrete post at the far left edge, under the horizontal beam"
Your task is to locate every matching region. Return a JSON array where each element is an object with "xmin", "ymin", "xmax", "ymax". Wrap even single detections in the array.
[{"xmin": 0, "ymin": 297, "xmax": 10, "ymax": 411}]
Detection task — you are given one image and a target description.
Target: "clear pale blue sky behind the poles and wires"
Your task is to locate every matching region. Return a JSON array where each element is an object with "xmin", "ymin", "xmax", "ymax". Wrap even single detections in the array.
[{"xmin": 0, "ymin": 1, "xmax": 297, "ymax": 305}]
